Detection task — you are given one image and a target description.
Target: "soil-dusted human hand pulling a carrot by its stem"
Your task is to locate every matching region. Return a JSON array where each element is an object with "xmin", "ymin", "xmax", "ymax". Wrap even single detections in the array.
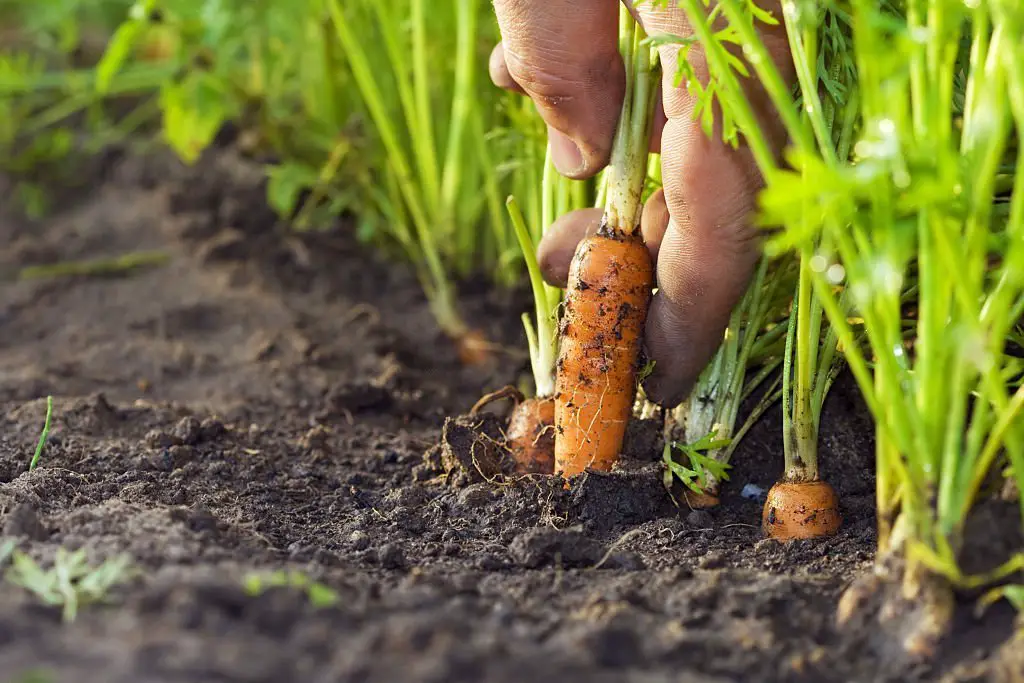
[{"xmin": 490, "ymin": 0, "xmax": 796, "ymax": 407}]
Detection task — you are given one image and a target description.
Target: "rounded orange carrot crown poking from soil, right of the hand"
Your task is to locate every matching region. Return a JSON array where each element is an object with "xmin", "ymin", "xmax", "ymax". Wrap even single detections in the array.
[{"xmin": 761, "ymin": 481, "xmax": 842, "ymax": 542}]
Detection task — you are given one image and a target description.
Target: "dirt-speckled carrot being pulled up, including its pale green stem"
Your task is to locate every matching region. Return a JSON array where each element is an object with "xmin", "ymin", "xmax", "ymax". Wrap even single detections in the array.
[{"xmin": 555, "ymin": 8, "xmax": 659, "ymax": 477}]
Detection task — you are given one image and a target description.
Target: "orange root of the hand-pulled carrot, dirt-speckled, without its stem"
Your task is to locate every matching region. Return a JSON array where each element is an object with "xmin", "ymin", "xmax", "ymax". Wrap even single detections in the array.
[{"xmin": 555, "ymin": 232, "xmax": 653, "ymax": 478}]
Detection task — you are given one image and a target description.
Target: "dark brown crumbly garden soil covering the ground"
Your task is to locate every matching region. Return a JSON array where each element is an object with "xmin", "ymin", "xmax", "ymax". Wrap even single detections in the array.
[{"xmin": 0, "ymin": 148, "xmax": 1024, "ymax": 683}]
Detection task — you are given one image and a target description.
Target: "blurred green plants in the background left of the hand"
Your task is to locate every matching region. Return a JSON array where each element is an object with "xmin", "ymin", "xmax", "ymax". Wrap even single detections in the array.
[{"xmin": 0, "ymin": 0, "xmax": 557, "ymax": 362}]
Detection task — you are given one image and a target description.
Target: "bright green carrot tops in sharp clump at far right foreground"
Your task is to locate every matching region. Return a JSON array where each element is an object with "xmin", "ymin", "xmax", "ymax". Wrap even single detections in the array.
[{"xmin": 663, "ymin": 0, "xmax": 1024, "ymax": 610}]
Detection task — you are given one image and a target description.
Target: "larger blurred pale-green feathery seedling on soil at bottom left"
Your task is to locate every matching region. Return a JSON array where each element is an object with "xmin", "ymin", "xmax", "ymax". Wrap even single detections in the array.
[{"xmin": 7, "ymin": 548, "xmax": 132, "ymax": 622}]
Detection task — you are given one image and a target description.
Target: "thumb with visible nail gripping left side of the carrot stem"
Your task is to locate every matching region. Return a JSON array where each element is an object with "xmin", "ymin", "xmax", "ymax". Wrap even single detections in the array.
[{"xmin": 490, "ymin": 0, "xmax": 626, "ymax": 179}]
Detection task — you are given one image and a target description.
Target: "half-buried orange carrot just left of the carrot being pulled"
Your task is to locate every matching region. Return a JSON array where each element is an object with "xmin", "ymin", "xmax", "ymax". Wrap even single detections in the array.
[{"xmin": 470, "ymin": 386, "xmax": 555, "ymax": 474}]
